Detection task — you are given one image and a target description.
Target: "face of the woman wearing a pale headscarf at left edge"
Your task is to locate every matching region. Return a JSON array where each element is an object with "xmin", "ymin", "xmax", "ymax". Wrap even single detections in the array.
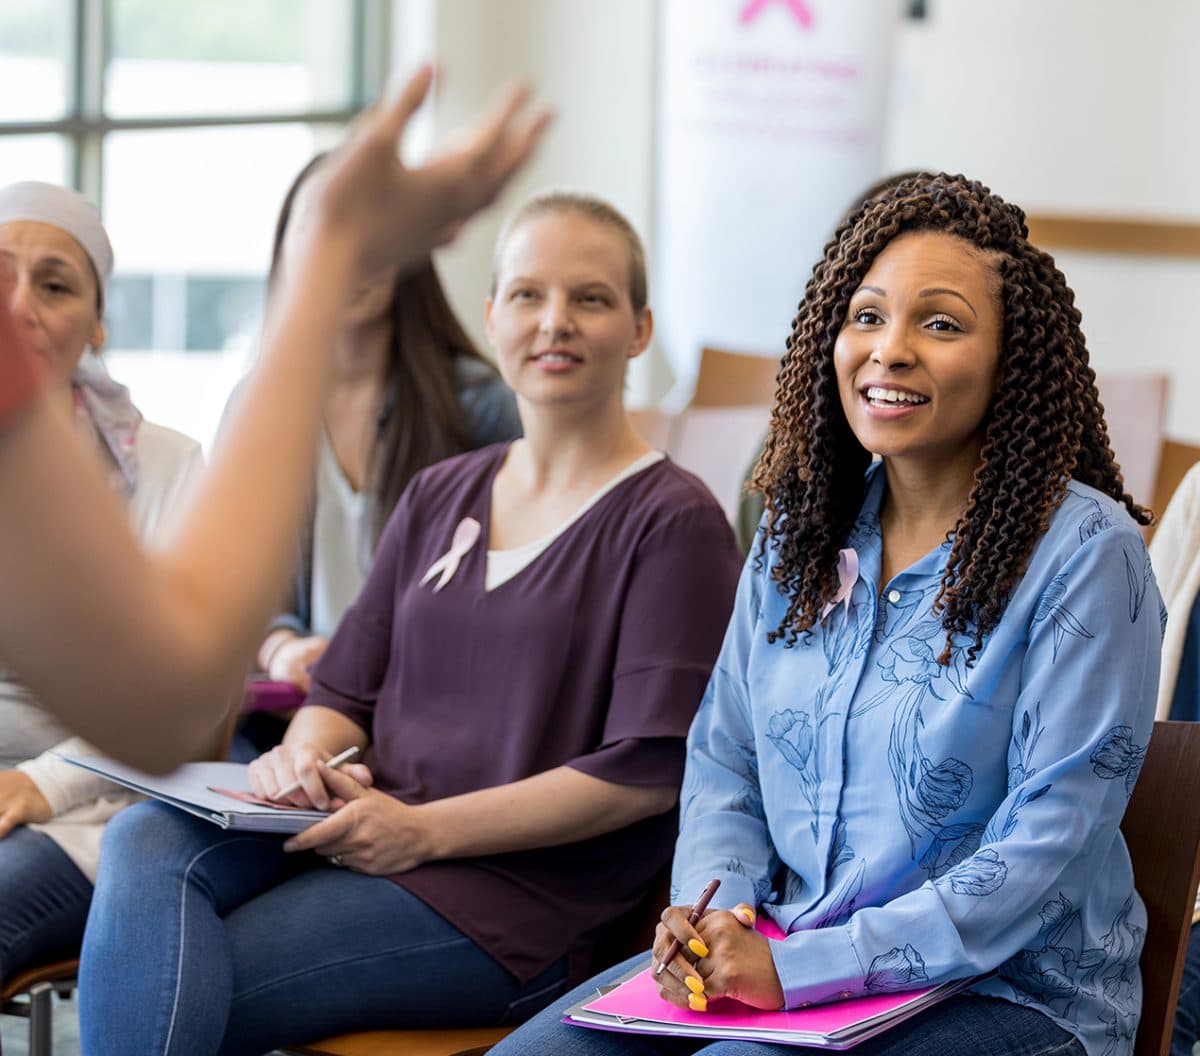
[{"xmin": 0, "ymin": 221, "xmax": 104, "ymax": 390}]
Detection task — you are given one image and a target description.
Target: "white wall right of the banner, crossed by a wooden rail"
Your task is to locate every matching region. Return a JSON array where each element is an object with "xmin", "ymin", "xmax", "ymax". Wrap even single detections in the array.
[{"xmin": 884, "ymin": 0, "xmax": 1200, "ymax": 443}]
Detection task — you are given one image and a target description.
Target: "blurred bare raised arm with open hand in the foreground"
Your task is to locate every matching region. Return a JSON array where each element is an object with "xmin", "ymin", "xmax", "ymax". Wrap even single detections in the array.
[{"xmin": 0, "ymin": 70, "xmax": 546, "ymax": 770}]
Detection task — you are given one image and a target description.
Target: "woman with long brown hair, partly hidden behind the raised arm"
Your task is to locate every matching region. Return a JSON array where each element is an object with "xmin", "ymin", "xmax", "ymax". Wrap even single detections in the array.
[{"xmin": 242, "ymin": 156, "xmax": 521, "ymax": 757}]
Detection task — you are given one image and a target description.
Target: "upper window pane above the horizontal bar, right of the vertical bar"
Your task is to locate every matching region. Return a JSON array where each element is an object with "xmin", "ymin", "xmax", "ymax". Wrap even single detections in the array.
[{"xmin": 104, "ymin": 0, "xmax": 356, "ymax": 118}]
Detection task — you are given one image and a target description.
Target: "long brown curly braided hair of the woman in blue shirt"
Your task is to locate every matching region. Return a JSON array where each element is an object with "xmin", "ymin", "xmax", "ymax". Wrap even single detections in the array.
[{"xmin": 751, "ymin": 173, "xmax": 1152, "ymax": 665}]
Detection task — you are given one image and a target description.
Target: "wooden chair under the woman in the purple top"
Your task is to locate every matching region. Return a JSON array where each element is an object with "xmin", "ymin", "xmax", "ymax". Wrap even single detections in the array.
[{"xmin": 284, "ymin": 868, "xmax": 671, "ymax": 1056}]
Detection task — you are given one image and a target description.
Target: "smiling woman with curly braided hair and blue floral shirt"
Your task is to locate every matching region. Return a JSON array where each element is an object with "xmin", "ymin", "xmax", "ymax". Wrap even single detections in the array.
[{"xmin": 494, "ymin": 174, "xmax": 1162, "ymax": 1056}]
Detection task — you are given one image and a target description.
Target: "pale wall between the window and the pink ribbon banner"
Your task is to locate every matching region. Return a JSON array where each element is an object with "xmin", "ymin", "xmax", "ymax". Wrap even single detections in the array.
[{"xmin": 394, "ymin": 0, "xmax": 670, "ymax": 397}]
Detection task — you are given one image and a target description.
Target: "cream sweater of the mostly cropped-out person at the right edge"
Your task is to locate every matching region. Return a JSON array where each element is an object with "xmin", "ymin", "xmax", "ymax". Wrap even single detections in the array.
[{"xmin": 1150, "ymin": 464, "xmax": 1200, "ymax": 719}]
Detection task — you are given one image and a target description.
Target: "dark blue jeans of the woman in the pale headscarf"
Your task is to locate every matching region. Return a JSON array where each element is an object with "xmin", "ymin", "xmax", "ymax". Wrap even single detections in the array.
[{"xmin": 0, "ymin": 826, "xmax": 91, "ymax": 980}]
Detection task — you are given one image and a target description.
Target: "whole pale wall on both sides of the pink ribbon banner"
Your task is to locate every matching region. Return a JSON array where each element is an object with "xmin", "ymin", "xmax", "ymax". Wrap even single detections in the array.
[{"xmin": 395, "ymin": 0, "xmax": 1200, "ymax": 443}]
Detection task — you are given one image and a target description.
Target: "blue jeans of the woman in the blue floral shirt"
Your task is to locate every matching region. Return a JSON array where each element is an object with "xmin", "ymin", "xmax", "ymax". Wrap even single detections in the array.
[{"xmin": 488, "ymin": 953, "xmax": 1084, "ymax": 1056}]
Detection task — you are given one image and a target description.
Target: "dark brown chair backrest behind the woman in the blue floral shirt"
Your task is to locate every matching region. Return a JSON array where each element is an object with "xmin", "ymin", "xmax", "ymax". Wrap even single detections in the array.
[{"xmin": 1121, "ymin": 722, "xmax": 1200, "ymax": 1056}]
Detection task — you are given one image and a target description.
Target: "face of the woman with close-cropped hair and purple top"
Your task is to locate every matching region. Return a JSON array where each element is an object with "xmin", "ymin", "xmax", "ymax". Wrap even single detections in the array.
[{"xmin": 487, "ymin": 211, "xmax": 653, "ymax": 415}]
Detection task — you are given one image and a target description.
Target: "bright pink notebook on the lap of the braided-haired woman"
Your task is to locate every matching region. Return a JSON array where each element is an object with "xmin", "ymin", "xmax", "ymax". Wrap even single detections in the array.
[{"xmin": 564, "ymin": 917, "xmax": 976, "ymax": 1049}]
